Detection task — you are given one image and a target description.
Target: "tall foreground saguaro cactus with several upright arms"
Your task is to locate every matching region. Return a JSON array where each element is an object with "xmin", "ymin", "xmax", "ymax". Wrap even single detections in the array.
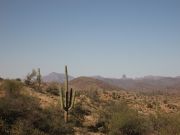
[{"xmin": 60, "ymin": 66, "xmax": 75, "ymax": 123}]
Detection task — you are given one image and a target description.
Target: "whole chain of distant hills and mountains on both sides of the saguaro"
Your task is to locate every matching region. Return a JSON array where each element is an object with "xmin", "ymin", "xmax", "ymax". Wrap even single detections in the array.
[{"xmin": 43, "ymin": 72, "xmax": 180, "ymax": 91}]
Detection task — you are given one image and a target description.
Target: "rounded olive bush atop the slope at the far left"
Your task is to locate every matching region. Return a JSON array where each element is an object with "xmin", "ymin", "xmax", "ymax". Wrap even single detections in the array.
[{"xmin": 2, "ymin": 80, "xmax": 23, "ymax": 96}]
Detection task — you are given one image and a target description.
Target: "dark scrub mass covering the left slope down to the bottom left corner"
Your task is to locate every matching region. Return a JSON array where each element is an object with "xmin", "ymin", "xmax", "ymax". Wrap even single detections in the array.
[{"xmin": 0, "ymin": 80, "xmax": 77, "ymax": 135}]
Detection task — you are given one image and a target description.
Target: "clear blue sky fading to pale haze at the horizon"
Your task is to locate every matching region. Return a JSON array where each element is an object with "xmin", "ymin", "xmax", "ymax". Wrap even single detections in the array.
[{"xmin": 0, "ymin": 0, "xmax": 180, "ymax": 78}]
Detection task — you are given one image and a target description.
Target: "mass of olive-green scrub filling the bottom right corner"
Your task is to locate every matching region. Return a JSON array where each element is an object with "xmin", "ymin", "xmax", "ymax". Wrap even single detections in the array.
[{"xmin": 94, "ymin": 98, "xmax": 180, "ymax": 135}]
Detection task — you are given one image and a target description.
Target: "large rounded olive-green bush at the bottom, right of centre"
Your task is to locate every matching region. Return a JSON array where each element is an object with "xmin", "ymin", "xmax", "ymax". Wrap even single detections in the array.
[{"xmin": 98, "ymin": 103, "xmax": 150, "ymax": 135}]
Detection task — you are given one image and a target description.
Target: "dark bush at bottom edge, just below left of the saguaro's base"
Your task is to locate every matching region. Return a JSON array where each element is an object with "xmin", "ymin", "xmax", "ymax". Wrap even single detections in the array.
[{"xmin": 32, "ymin": 108, "xmax": 74, "ymax": 135}]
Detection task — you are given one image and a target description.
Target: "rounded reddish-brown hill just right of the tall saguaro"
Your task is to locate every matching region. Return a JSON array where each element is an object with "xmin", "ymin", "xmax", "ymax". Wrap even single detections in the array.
[{"xmin": 70, "ymin": 77, "xmax": 122, "ymax": 90}]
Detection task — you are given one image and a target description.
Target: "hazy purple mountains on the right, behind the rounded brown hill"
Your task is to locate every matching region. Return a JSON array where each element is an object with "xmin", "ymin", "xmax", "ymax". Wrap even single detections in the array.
[{"xmin": 95, "ymin": 76, "xmax": 180, "ymax": 91}]
